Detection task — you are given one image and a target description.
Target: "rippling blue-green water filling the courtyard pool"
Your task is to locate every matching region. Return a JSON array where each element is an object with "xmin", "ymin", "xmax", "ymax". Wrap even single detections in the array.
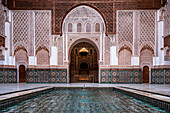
[{"xmin": 2, "ymin": 89, "xmax": 166, "ymax": 113}]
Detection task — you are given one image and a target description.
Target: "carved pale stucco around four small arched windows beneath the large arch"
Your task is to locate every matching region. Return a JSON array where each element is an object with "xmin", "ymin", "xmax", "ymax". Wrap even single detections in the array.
[{"xmin": 63, "ymin": 6, "xmax": 104, "ymax": 32}]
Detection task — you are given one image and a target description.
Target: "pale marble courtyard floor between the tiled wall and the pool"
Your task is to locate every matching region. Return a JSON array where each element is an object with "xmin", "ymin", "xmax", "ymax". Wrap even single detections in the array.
[{"xmin": 0, "ymin": 83, "xmax": 170, "ymax": 96}]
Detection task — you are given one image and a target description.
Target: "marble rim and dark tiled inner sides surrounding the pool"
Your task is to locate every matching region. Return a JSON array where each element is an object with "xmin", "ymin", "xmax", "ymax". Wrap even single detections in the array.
[{"xmin": 0, "ymin": 87, "xmax": 170, "ymax": 112}]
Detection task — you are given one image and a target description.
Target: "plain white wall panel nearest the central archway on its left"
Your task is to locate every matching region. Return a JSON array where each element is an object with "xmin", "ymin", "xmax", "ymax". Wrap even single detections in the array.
[{"xmin": 50, "ymin": 46, "xmax": 58, "ymax": 65}]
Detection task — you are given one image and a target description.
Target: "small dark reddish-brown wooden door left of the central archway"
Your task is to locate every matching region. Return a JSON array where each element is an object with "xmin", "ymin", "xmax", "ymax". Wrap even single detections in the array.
[{"xmin": 19, "ymin": 65, "xmax": 26, "ymax": 82}]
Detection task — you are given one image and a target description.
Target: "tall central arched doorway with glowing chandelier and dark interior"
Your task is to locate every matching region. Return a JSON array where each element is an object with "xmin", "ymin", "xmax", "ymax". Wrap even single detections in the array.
[{"xmin": 70, "ymin": 42, "xmax": 98, "ymax": 83}]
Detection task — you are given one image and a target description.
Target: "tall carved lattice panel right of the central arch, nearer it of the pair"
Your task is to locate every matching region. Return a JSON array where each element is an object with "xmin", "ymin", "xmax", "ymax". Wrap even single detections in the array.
[{"xmin": 118, "ymin": 11, "xmax": 133, "ymax": 44}]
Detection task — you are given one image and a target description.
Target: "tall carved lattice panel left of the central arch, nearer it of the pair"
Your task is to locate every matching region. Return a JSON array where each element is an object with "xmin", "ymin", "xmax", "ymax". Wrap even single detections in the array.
[{"xmin": 35, "ymin": 11, "xmax": 51, "ymax": 48}]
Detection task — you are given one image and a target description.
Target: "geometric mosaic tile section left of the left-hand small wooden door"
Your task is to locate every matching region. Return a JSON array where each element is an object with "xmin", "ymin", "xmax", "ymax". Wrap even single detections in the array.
[{"xmin": 0, "ymin": 68, "xmax": 17, "ymax": 83}]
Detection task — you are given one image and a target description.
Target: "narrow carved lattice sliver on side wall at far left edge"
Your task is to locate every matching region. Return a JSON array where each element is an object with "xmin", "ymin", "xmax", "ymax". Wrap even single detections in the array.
[{"xmin": 0, "ymin": 4, "xmax": 5, "ymax": 36}]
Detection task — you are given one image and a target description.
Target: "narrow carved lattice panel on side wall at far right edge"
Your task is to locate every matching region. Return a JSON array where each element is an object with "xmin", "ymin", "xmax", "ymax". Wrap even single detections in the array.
[{"xmin": 164, "ymin": 1, "xmax": 170, "ymax": 36}]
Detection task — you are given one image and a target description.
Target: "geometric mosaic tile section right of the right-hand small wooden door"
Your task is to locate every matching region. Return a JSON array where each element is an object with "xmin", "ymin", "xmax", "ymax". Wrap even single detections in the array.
[{"xmin": 151, "ymin": 69, "xmax": 170, "ymax": 84}]
